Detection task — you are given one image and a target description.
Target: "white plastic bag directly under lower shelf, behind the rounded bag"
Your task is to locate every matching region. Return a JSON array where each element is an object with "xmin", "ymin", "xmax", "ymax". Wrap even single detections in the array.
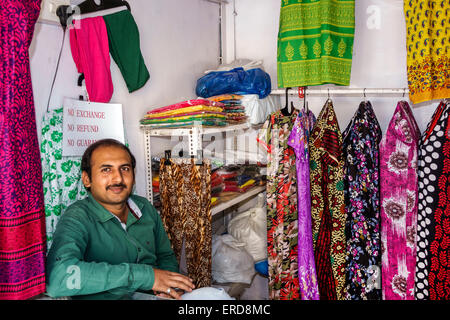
[{"xmin": 228, "ymin": 194, "xmax": 267, "ymax": 262}]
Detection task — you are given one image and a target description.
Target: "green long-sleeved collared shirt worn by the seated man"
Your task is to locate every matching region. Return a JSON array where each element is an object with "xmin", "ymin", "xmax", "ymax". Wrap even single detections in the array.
[{"xmin": 47, "ymin": 194, "xmax": 178, "ymax": 299}]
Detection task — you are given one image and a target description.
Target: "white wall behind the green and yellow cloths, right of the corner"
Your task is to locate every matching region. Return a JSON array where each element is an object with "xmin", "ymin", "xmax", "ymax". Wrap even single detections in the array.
[{"xmin": 225, "ymin": 0, "xmax": 439, "ymax": 132}]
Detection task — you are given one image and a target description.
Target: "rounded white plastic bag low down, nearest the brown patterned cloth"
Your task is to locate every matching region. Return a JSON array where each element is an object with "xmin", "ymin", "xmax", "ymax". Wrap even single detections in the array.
[{"xmin": 211, "ymin": 234, "xmax": 256, "ymax": 284}]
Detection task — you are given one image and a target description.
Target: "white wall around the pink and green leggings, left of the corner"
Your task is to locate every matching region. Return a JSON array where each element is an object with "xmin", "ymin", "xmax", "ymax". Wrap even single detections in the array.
[{"xmin": 30, "ymin": 0, "xmax": 219, "ymax": 196}]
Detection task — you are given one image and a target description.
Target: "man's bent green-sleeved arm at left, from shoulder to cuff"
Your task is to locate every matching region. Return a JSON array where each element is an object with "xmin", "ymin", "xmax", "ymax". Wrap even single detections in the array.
[{"xmin": 47, "ymin": 211, "xmax": 154, "ymax": 297}]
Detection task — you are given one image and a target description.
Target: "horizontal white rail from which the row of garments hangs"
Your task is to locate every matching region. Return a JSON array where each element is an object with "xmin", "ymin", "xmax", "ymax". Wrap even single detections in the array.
[{"xmin": 270, "ymin": 88, "xmax": 409, "ymax": 96}]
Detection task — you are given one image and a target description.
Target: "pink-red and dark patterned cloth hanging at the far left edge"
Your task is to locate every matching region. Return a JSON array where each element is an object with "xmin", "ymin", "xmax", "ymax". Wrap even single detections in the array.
[{"xmin": 0, "ymin": 0, "xmax": 46, "ymax": 300}]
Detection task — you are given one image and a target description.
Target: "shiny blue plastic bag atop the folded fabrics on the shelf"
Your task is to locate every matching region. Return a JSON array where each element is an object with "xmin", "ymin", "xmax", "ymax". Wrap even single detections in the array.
[{"xmin": 195, "ymin": 68, "xmax": 272, "ymax": 99}]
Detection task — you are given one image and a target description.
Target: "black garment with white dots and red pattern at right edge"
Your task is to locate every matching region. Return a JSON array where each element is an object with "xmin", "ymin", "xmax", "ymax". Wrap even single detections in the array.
[{"xmin": 415, "ymin": 102, "xmax": 450, "ymax": 300}]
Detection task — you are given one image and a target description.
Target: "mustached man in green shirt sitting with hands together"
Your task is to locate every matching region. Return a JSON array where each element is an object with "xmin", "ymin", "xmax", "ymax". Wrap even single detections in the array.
[{"xmin": 47, "ymin": 139, "xmax": 194, "ymax": 299}]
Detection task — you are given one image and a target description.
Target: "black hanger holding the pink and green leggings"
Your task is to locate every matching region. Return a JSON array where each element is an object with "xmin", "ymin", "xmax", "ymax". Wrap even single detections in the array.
[{"xmin": 56, "ymin": 0, "xmax": 131, "ymax": 29}]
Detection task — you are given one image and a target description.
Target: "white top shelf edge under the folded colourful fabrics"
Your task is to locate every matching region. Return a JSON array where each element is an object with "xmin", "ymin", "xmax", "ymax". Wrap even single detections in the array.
[{"xmin": 140, "ymin": 122, "xmax": 252, "ymax": 137}]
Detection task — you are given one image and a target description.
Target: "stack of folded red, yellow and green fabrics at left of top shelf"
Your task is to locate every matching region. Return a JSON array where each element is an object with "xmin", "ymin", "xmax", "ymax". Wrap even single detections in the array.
[{"xmin": 140, "ymin": 99, "xmax": 227, "ymax": 128}]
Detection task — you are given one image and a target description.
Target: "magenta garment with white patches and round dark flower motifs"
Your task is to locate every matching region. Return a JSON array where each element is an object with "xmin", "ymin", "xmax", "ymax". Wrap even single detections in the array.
[{"xmin": 380, "ymin": 101, "xmax": 420, "ymax": 300}]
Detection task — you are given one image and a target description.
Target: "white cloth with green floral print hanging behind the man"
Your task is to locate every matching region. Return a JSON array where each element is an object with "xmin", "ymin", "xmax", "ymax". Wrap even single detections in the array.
[{"xmin": 41, "ymin": 108, "xmax": 87, "ymax": 249}]
